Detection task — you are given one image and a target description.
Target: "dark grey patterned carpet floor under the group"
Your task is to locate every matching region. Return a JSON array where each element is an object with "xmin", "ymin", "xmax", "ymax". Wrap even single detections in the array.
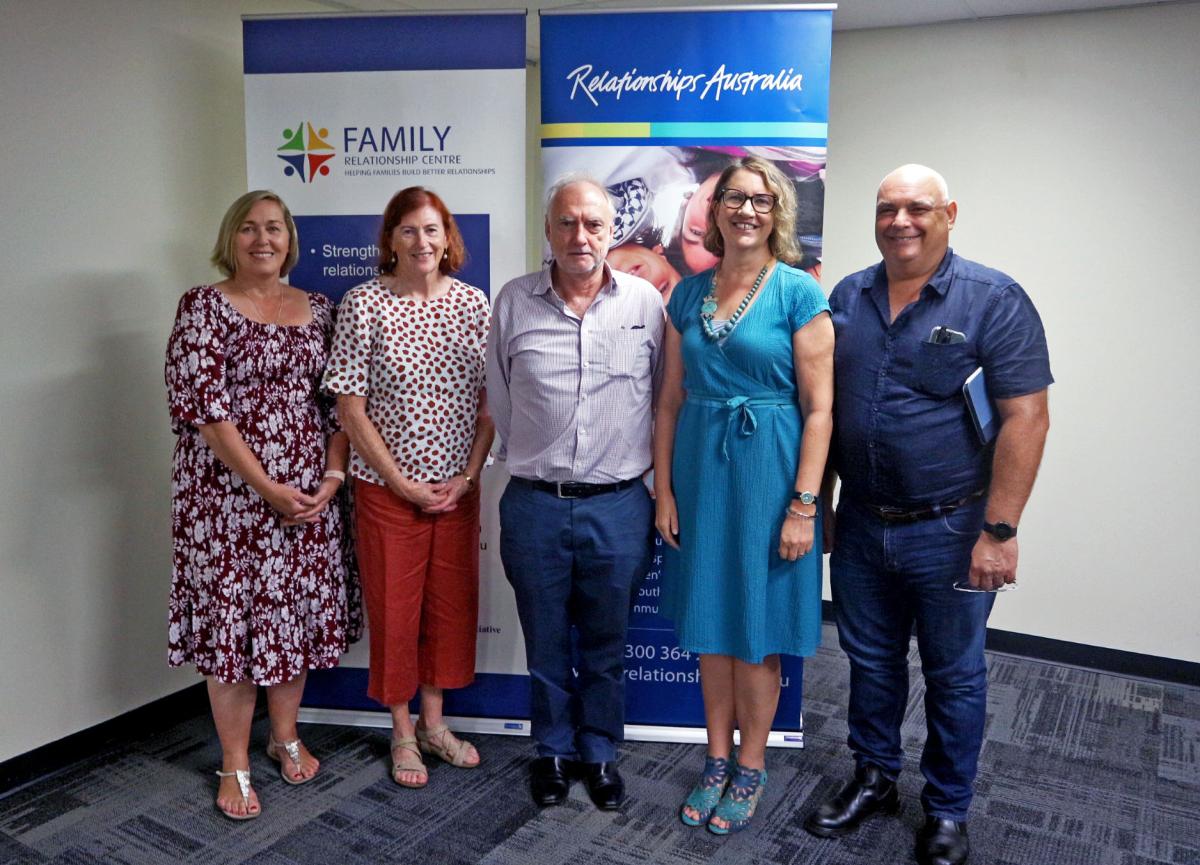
[{"xmin": 0, "ymin": 626, "xmax": 1200, "ymax": 865}]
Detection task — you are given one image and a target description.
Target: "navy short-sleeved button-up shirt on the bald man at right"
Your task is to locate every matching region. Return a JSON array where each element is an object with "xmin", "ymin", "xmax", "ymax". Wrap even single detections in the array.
[{"xmin": 829, "ymin": 250, "xmax": 1054, "ymax": 506}]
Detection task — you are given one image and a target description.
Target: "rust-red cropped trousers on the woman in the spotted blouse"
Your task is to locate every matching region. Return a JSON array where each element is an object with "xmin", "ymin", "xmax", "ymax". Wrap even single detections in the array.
[{"xmin": 354, "ymin": 479, "xmax": 479, "ymax": 705}]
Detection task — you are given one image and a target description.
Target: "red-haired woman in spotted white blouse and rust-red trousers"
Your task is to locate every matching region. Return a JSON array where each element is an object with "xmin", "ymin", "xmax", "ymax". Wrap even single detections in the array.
[{"xmin": 323, "ymin": 186, "xmax": 493, "ymax": 787}]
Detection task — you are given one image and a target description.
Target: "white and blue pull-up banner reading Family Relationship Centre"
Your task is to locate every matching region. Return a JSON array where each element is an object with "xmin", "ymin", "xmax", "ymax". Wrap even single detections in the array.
[{"xmin": 242, "ymin": 12, "xmax": 528, "ymax": 732}]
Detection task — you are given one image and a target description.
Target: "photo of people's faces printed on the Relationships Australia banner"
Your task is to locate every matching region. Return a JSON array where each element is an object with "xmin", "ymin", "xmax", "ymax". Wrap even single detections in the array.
[{"xmin": 542, "ymin": 146, "xmax": 826, "ymax": 302}]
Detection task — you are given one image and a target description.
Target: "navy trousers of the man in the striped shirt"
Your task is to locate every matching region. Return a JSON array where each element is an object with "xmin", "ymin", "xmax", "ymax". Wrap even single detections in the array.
[{"xmin": 500, "ymin": 482, "xmax": 654, "ymax": 763}]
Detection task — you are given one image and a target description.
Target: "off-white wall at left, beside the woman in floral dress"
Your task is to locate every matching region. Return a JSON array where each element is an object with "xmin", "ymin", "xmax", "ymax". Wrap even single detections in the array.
[{"xmin": 0, "ymin": 0, "xmax": 328, "ymax": 759}]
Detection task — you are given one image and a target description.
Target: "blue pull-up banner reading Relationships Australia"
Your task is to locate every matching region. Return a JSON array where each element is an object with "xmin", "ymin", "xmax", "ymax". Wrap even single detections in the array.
[{"xmin": 541, "ymin": 5, "xmax": 834, "ymax": 746}]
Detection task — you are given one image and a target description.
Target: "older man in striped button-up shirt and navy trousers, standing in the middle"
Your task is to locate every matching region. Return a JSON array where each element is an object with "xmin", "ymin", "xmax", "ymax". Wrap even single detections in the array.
[{"xmin": 487, "ymin": 176, "xmax": 664, "ymax": 810}]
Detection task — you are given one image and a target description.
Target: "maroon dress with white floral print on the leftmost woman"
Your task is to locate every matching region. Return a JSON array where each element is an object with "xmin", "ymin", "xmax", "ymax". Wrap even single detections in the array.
[{"xmin": 167, "ymin": 286, "xmax": 362, "ymax": 685}]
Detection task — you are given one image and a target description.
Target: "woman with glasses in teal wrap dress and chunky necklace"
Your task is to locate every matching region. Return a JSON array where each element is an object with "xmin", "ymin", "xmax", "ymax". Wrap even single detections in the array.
[{"xmin": 654, "ymin": 157, "xmax": 833, "ymax": 835}]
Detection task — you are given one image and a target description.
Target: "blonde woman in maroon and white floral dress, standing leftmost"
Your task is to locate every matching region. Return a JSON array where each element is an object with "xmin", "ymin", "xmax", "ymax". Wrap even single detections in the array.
[{"xmin": 167, "ymin": 191, "xmax": 361, "ymax": 819}]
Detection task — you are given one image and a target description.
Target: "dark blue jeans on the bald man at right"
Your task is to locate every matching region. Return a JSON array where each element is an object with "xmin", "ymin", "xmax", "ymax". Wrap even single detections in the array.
[{"xmin": 829, "ymin": 498, "xmax": 995, "ymax": 821}]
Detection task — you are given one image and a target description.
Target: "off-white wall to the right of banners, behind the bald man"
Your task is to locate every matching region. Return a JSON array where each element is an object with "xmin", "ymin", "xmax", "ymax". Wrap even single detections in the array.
[{"xmin": 824, "ymin": 4, "xmax": 1200, "ymax": 661}]
